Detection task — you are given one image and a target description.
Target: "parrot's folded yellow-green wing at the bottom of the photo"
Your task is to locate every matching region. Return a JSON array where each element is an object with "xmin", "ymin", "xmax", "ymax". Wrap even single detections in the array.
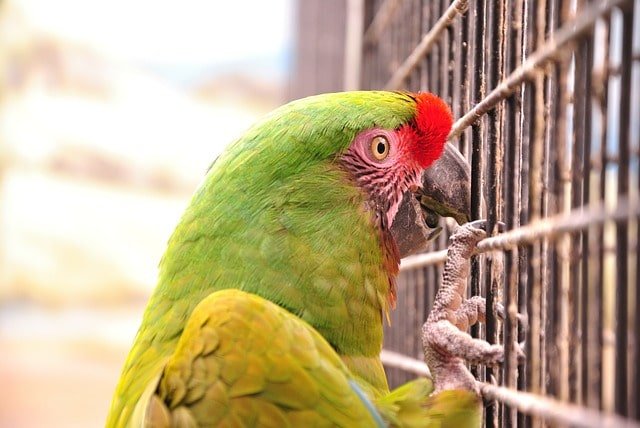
[{"xmin": 137, "ymin": 290, "xmax": 376, "ymax": 427}]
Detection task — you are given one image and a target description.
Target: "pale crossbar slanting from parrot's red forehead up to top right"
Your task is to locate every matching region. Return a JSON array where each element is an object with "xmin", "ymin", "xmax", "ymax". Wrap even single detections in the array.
[{"xmin": 448, "ymin": 0, "xmax": 631, "ymax": 140}]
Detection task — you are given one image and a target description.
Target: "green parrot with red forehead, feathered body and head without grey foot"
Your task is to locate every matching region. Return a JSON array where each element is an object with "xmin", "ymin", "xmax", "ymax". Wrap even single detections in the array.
[{"xmin": 106, "ymin": 91, "xmax": 481, "ymax": 427}]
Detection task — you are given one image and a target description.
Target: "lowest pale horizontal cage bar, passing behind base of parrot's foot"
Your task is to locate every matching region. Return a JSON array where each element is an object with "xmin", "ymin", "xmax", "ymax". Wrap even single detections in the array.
[{"xmin": 380, "ymin": 349, "xmax": 640, "ymax": 428}]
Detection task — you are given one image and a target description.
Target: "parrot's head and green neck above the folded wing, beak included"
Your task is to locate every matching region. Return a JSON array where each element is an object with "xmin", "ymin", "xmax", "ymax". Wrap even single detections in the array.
[{"xmin": 145, "ymin": 91, "xmax": 470, "ymax": 355}]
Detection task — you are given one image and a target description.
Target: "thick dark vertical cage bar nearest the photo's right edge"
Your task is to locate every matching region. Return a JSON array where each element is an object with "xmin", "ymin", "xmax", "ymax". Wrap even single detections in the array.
[{"xmin": 615, "ymin": 2, "xmax": 637, "ymax": 416}]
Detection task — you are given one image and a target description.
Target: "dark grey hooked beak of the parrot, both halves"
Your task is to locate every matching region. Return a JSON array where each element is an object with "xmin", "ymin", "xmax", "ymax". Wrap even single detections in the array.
[{"xmin": 391, "ymin": 143, "xmax": 471, "ymax": 257}]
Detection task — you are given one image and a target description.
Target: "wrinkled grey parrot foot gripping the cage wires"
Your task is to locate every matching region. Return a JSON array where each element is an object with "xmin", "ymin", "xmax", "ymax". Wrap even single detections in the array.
[{"xmin": 422, "ymin": 220, "xmax": 526, "ymax": 393}]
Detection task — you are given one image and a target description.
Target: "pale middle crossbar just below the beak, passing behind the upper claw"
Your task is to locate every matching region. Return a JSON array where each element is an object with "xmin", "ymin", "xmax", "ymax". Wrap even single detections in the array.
[{"xmin": 400, "ymin": 199, "xmax": 640, "ymax": 271}]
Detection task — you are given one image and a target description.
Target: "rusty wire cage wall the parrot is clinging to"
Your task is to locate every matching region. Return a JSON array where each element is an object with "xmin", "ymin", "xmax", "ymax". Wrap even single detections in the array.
[{"xmin": 360, "ymin": 0, "xmax": 640, "ymax": 426}]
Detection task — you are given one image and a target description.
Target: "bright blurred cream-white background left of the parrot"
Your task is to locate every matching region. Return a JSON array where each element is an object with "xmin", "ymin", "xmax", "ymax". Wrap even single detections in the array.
[{"xmin": 0, "ymin": 0, "xmax": 295, "ymax": 427}]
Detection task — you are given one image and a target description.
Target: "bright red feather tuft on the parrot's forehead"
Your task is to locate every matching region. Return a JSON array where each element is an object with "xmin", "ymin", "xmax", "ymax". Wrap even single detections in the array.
[{"xmin": 399, "ymin": 92, "xmax": 453, "ymax": 168}]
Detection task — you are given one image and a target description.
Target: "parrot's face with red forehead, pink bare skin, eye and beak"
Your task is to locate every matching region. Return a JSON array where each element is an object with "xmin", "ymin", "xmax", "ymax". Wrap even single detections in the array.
[{"xmin": 341, "ymin": 93, "xmax": 470, "ymax": 257}]
